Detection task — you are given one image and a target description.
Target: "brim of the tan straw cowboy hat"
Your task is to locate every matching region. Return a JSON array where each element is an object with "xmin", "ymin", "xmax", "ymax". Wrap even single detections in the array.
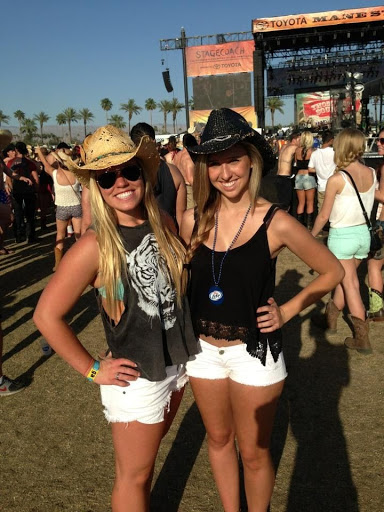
[{"xmin": 65, "ymin": 136, "xmax": 160, "ymax": 187}]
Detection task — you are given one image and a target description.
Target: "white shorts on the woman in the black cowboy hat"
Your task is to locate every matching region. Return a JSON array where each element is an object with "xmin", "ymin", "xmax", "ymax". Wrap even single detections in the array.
[{"xmin": 187, "ymin": 339, "xmax": 287, "ymax": 386}]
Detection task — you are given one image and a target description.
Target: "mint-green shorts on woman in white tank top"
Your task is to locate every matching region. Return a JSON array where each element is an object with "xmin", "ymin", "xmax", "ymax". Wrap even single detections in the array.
[{"xmin": 328, "ymin": 224, "xmax": 371, "ymax": 260}]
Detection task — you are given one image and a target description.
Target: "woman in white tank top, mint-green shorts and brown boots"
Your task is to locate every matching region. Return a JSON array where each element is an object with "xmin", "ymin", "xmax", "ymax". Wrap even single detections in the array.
[{"xmin": 312, "ymin": 128, "xmax": 376, "ymax": 354}]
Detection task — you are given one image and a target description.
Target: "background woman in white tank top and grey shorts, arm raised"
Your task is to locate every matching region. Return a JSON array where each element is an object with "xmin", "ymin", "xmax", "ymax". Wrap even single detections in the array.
[{"xmin": 35, "ymin": 146, "xmax": 82, "ymax": 270}]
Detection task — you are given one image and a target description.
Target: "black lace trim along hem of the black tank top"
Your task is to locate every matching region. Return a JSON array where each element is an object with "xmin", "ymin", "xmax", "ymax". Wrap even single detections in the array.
[{"xmin": 198, "ymin": 319, "xmax": 282, "ymax": 366}]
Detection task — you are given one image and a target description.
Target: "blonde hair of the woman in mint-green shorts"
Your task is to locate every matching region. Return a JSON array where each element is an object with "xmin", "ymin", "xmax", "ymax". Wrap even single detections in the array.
[{"xmin": 333, "ymin": 128, "xmax": 365, "ymax": 171}]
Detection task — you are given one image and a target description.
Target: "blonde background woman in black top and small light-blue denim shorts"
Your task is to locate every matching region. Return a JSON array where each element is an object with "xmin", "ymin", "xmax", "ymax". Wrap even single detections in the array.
[{"xmin": 295, "ymin": 131, "xmax": 316, "ymax": 229}]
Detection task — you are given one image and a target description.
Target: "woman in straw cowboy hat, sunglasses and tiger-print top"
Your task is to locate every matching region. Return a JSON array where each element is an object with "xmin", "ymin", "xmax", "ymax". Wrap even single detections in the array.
[{"xmin": 34, "ymin": 125, "xmax": 197, "ymax": 512}]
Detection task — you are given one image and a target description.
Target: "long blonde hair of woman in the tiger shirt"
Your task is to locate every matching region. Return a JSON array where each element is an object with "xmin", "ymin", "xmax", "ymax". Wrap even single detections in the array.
[{"xmin": 89, "ymin": 163, "xmax": 185, "ymax": 312}]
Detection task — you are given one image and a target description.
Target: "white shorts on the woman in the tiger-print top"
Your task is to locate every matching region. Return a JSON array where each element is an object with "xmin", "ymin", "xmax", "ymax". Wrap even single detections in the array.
[{"xmin": 100, "ymin": 365, "xmax": 188, "ymax": 424}]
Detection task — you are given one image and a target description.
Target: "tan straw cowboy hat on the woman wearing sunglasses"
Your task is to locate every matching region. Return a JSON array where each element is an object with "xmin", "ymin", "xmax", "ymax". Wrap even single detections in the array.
[{"xmin": 65, "ymin": 125, "xmax": 160, "ymax": 187}]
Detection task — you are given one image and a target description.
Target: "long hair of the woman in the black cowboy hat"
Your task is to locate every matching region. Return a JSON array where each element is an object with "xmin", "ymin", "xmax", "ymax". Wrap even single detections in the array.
[{"xmin": 186, "ymin": 142, "xmax": 263, "ymax": 263}]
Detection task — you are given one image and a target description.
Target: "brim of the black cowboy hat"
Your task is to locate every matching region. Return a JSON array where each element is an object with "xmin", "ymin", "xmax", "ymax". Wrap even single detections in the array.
[{"xmin": 187, "ymin": 130, "xmax": 276, "ymax": 174}]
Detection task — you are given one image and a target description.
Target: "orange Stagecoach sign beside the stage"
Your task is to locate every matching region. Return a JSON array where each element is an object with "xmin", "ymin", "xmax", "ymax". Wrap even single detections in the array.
[{"xmin": 185, "ymin": 41, "xmax": 254, "ymax": 76}]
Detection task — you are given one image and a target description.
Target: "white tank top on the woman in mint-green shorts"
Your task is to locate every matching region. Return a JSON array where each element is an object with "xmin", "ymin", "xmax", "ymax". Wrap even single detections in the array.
[{"xmin": 329, "ymin": 169, "xmax": 376, "ymax": 228}]
